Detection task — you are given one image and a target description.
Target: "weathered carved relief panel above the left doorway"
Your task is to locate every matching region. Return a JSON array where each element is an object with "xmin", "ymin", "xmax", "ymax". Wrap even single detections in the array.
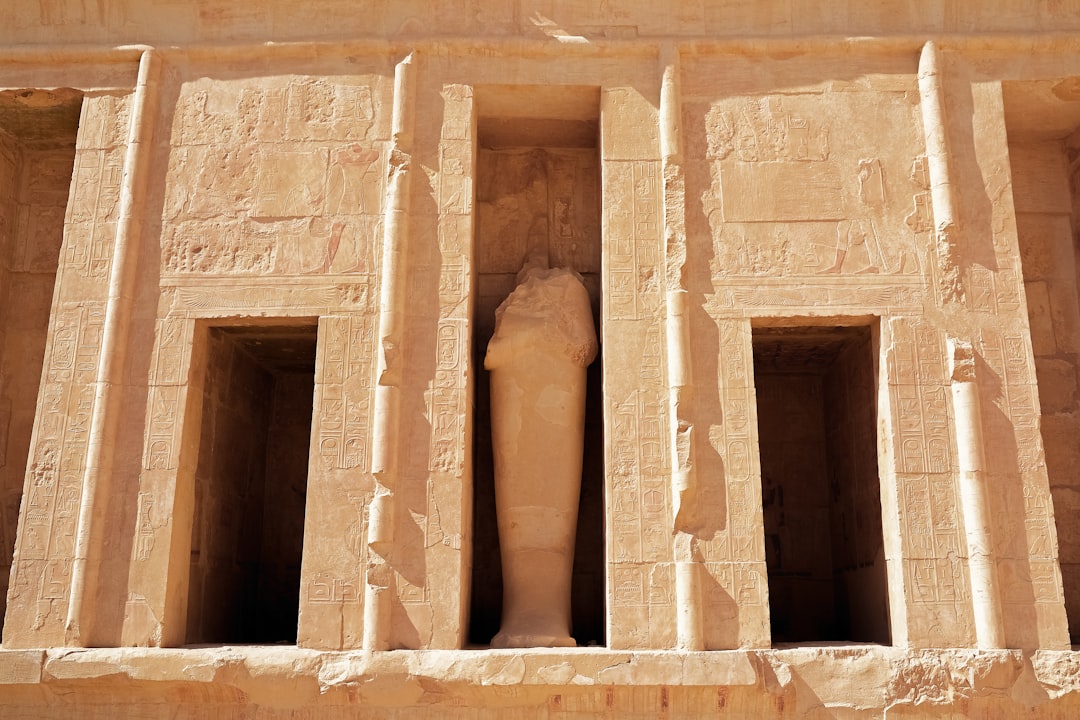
[{"xmin": 161, "ymin": 71, "xmax": 391, "ymax": 276}]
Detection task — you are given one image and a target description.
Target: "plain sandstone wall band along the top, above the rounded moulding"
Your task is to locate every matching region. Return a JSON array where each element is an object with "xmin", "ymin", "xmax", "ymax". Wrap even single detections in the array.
[{"xmin": 6, "ymin": 0, "xmax": 1080, "ymax": 44}]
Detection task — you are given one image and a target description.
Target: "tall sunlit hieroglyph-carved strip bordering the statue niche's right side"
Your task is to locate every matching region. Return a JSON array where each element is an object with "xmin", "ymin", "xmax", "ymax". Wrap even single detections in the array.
[{"xmin": 603, "ymin": 146, "xmax": 675, "ymax": 648}]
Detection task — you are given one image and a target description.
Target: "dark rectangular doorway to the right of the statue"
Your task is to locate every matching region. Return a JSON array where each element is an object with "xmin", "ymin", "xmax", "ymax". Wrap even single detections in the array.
[{"xmin": 753, "ymin": 326, "xmax": 890, "ymax": 643}]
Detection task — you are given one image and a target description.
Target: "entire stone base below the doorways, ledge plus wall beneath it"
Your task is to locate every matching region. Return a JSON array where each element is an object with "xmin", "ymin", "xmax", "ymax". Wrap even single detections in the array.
[{"xmin": 0, "ymin": 646, "xmax": 1080, "ymax": 718}]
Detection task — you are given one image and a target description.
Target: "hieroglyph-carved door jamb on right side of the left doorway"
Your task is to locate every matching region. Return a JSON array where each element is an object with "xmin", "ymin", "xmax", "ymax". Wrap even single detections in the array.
[{"xmin": 298, "ymin": 315, "xmax": 376, "ymax": 650}]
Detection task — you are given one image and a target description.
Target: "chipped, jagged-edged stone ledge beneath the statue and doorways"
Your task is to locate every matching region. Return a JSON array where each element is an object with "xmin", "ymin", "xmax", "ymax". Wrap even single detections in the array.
[{"xmin": 0, "ymin": 646, "xmax": 1080, "ymax": 710}]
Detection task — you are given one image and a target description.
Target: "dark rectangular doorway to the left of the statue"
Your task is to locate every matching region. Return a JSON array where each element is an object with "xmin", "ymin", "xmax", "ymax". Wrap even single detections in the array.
[{"xmin": 186, "ymin": 324, "xmax": 316, "ymax": 644}]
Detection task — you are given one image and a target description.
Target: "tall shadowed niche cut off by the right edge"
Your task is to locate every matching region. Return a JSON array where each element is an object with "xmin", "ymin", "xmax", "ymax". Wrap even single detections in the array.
[{"xmin": 1002, "ymin": 78, "xmax": 1080, "ymax": 646}]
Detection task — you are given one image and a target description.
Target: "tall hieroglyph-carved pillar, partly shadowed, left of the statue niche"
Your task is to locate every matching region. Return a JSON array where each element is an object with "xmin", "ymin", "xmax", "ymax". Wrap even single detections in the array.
[{"xmin": 381, "ymin": 81, "xmax": 478, "ymax": 648}]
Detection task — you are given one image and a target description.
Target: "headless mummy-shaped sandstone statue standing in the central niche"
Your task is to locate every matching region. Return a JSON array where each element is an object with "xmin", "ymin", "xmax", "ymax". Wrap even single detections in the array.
[{"xmin": 484, "ymin": 256, "xmax": 597, "ymax": 648}]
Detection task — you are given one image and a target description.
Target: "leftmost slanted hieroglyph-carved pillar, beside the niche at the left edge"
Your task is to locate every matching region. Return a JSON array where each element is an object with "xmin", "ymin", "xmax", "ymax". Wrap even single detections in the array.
[{"xmin": 3, "ymin": 96, "xmax": 130, "ymax": 648}]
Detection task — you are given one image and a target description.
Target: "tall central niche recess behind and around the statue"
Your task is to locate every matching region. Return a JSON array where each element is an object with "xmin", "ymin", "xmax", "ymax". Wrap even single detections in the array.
[{"xmin": 468, "ymin": 85, "xmax": 606, "ymax": 646}]
